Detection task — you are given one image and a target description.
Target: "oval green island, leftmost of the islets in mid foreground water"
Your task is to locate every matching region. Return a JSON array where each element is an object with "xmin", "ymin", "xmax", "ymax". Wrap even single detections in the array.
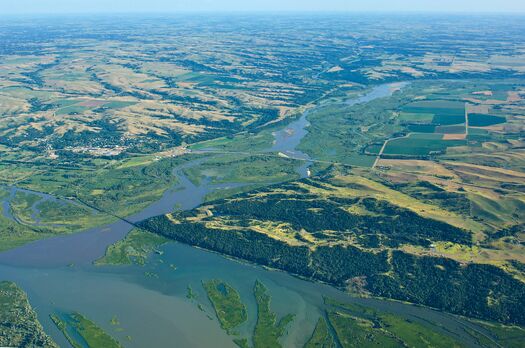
[{"xmin": 202, "ymin": 280, "xmax": 248, "ymax": 334}]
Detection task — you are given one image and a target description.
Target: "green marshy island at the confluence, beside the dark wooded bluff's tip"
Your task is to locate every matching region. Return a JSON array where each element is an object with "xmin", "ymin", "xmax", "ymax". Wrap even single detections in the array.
[{"xmin": 95, "ymin": 229, "xmax": 167, "ymax": 266}]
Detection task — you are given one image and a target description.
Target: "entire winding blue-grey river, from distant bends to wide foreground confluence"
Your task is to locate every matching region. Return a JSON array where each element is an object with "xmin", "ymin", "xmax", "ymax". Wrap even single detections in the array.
[{"xmin": 0, "ymin": 85, "xmax": 492, "ymax": 347}]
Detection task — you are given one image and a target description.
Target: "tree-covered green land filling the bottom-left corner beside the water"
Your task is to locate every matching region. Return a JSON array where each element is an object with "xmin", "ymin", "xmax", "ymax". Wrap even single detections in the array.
[{"xmin": 0, "ymin": 281, "xmax": 58, "ymax": 348}]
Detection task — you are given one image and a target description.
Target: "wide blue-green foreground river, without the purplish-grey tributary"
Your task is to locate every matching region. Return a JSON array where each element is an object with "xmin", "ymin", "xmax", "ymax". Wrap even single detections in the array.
[{"xmin": 0, "ymin": 243, "xmax": 492, "ymax": 347}]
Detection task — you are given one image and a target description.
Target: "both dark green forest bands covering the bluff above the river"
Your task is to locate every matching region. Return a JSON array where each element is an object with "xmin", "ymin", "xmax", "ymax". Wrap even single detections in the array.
[{"xmin": 141, "ymin": 179, "xmax": 525, "ymax": 324}]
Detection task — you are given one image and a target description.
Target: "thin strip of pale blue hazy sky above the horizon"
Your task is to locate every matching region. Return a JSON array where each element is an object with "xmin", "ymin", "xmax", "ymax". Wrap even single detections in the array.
[{"xmin": 0, "ymin": 0, "xmax": 525, "ymax": 14}]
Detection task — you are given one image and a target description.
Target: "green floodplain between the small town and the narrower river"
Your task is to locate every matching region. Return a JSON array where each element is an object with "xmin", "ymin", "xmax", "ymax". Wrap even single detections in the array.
[{"xmin": 18, "ymin": 158, "xmax": 192, "ymax": 217}]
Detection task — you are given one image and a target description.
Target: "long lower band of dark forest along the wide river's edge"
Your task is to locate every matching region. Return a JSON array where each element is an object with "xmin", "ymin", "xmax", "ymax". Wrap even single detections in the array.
[{"xmin": 141, "ymin": 216, "xmax": 525, "ymax": 325}]
